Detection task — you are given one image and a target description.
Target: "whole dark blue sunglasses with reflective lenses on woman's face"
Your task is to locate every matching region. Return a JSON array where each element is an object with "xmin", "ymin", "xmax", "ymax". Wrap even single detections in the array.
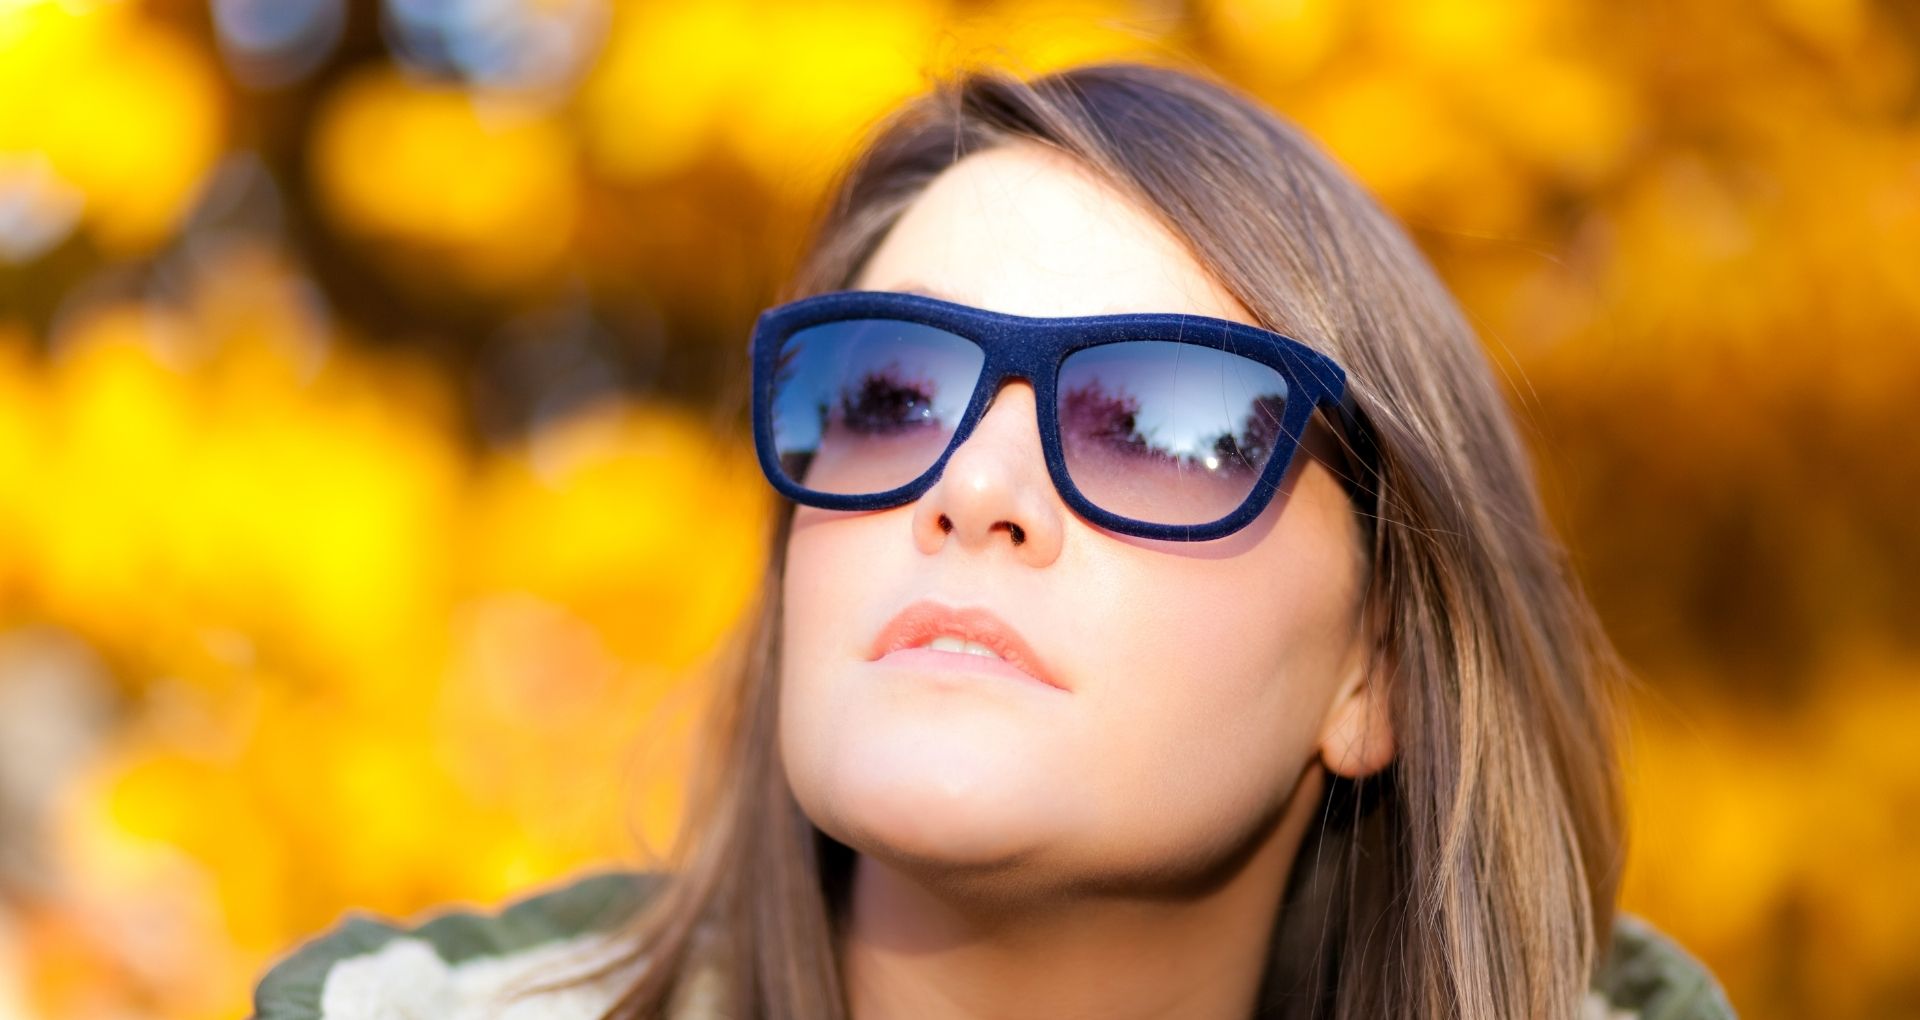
[{"xmin": 749, "ymin": 290, "xmax": 1375, "ymax": 542}]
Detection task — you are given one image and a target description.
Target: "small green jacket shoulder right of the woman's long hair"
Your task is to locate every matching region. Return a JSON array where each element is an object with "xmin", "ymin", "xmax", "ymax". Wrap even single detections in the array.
[{"xmin": 1582, "ymin": 912, "xmax": 1734, "ymax": 1020}]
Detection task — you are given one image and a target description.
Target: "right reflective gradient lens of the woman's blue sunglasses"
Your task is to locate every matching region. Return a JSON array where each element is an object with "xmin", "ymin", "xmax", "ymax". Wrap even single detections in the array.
[{"xmin": 1058, "ymin": 340, "xmax": 1288, "ymax": 524}]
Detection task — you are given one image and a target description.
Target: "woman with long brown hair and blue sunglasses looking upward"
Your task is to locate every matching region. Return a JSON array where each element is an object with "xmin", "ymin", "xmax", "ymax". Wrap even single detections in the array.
[{"xmin": 257, "ymin": 63, "xmax": 1732, "ymax": 1020}]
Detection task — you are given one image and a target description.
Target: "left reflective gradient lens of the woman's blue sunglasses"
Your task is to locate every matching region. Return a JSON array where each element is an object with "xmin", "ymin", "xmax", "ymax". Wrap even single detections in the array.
[{"xmin": 770, "ymin": 319, "xmax": 987, "ymax": 496}]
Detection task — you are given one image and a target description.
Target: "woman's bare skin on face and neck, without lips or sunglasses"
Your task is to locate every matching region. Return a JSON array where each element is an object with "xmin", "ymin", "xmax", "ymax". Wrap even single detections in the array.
[{"xmin": 780, "ymin": 142, "xmax": 1394, "ymax": 1020}]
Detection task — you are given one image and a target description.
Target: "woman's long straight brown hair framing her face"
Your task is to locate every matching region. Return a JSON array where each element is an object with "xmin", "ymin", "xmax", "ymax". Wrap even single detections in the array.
[{"xmin": 522, "ymin": 63, "xmax": 1624, "ymax": 1020}]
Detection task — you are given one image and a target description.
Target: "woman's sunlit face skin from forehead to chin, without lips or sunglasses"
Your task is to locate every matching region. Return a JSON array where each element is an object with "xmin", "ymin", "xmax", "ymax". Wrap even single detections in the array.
[{"xmin": 780, "ymin": 144, "xmax": 1392, "ymax": 887}]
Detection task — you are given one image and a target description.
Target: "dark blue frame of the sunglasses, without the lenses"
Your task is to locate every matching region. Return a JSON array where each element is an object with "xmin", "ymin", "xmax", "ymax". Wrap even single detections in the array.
[{"xmin": 747, "ymin": 290, "xmax": 1379, "ymax": 542}]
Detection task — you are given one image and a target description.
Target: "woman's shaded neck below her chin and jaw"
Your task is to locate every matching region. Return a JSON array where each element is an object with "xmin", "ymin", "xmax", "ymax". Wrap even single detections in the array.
[{"xmin": 841, "ymin": 763, "xmax": 1325, "ymax": 1020}]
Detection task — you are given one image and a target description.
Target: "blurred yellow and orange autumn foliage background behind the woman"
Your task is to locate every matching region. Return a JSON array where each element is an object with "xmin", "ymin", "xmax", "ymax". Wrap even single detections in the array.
[{"xmin": 0, "ymin": 0, "xmax": 1920, "ymax": 1020}]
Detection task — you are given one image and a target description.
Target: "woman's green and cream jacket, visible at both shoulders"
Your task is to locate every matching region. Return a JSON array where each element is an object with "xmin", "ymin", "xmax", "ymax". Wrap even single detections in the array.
[{"xmin": 248, "ymin": 870, "xmax": 1734, "ymax": 1020}]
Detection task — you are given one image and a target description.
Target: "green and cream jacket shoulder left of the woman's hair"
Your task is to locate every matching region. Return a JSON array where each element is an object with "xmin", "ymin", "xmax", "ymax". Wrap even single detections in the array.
[{"xmin": 250, "ymin": 870, "xmax": 666, "ymax": 1020}]
